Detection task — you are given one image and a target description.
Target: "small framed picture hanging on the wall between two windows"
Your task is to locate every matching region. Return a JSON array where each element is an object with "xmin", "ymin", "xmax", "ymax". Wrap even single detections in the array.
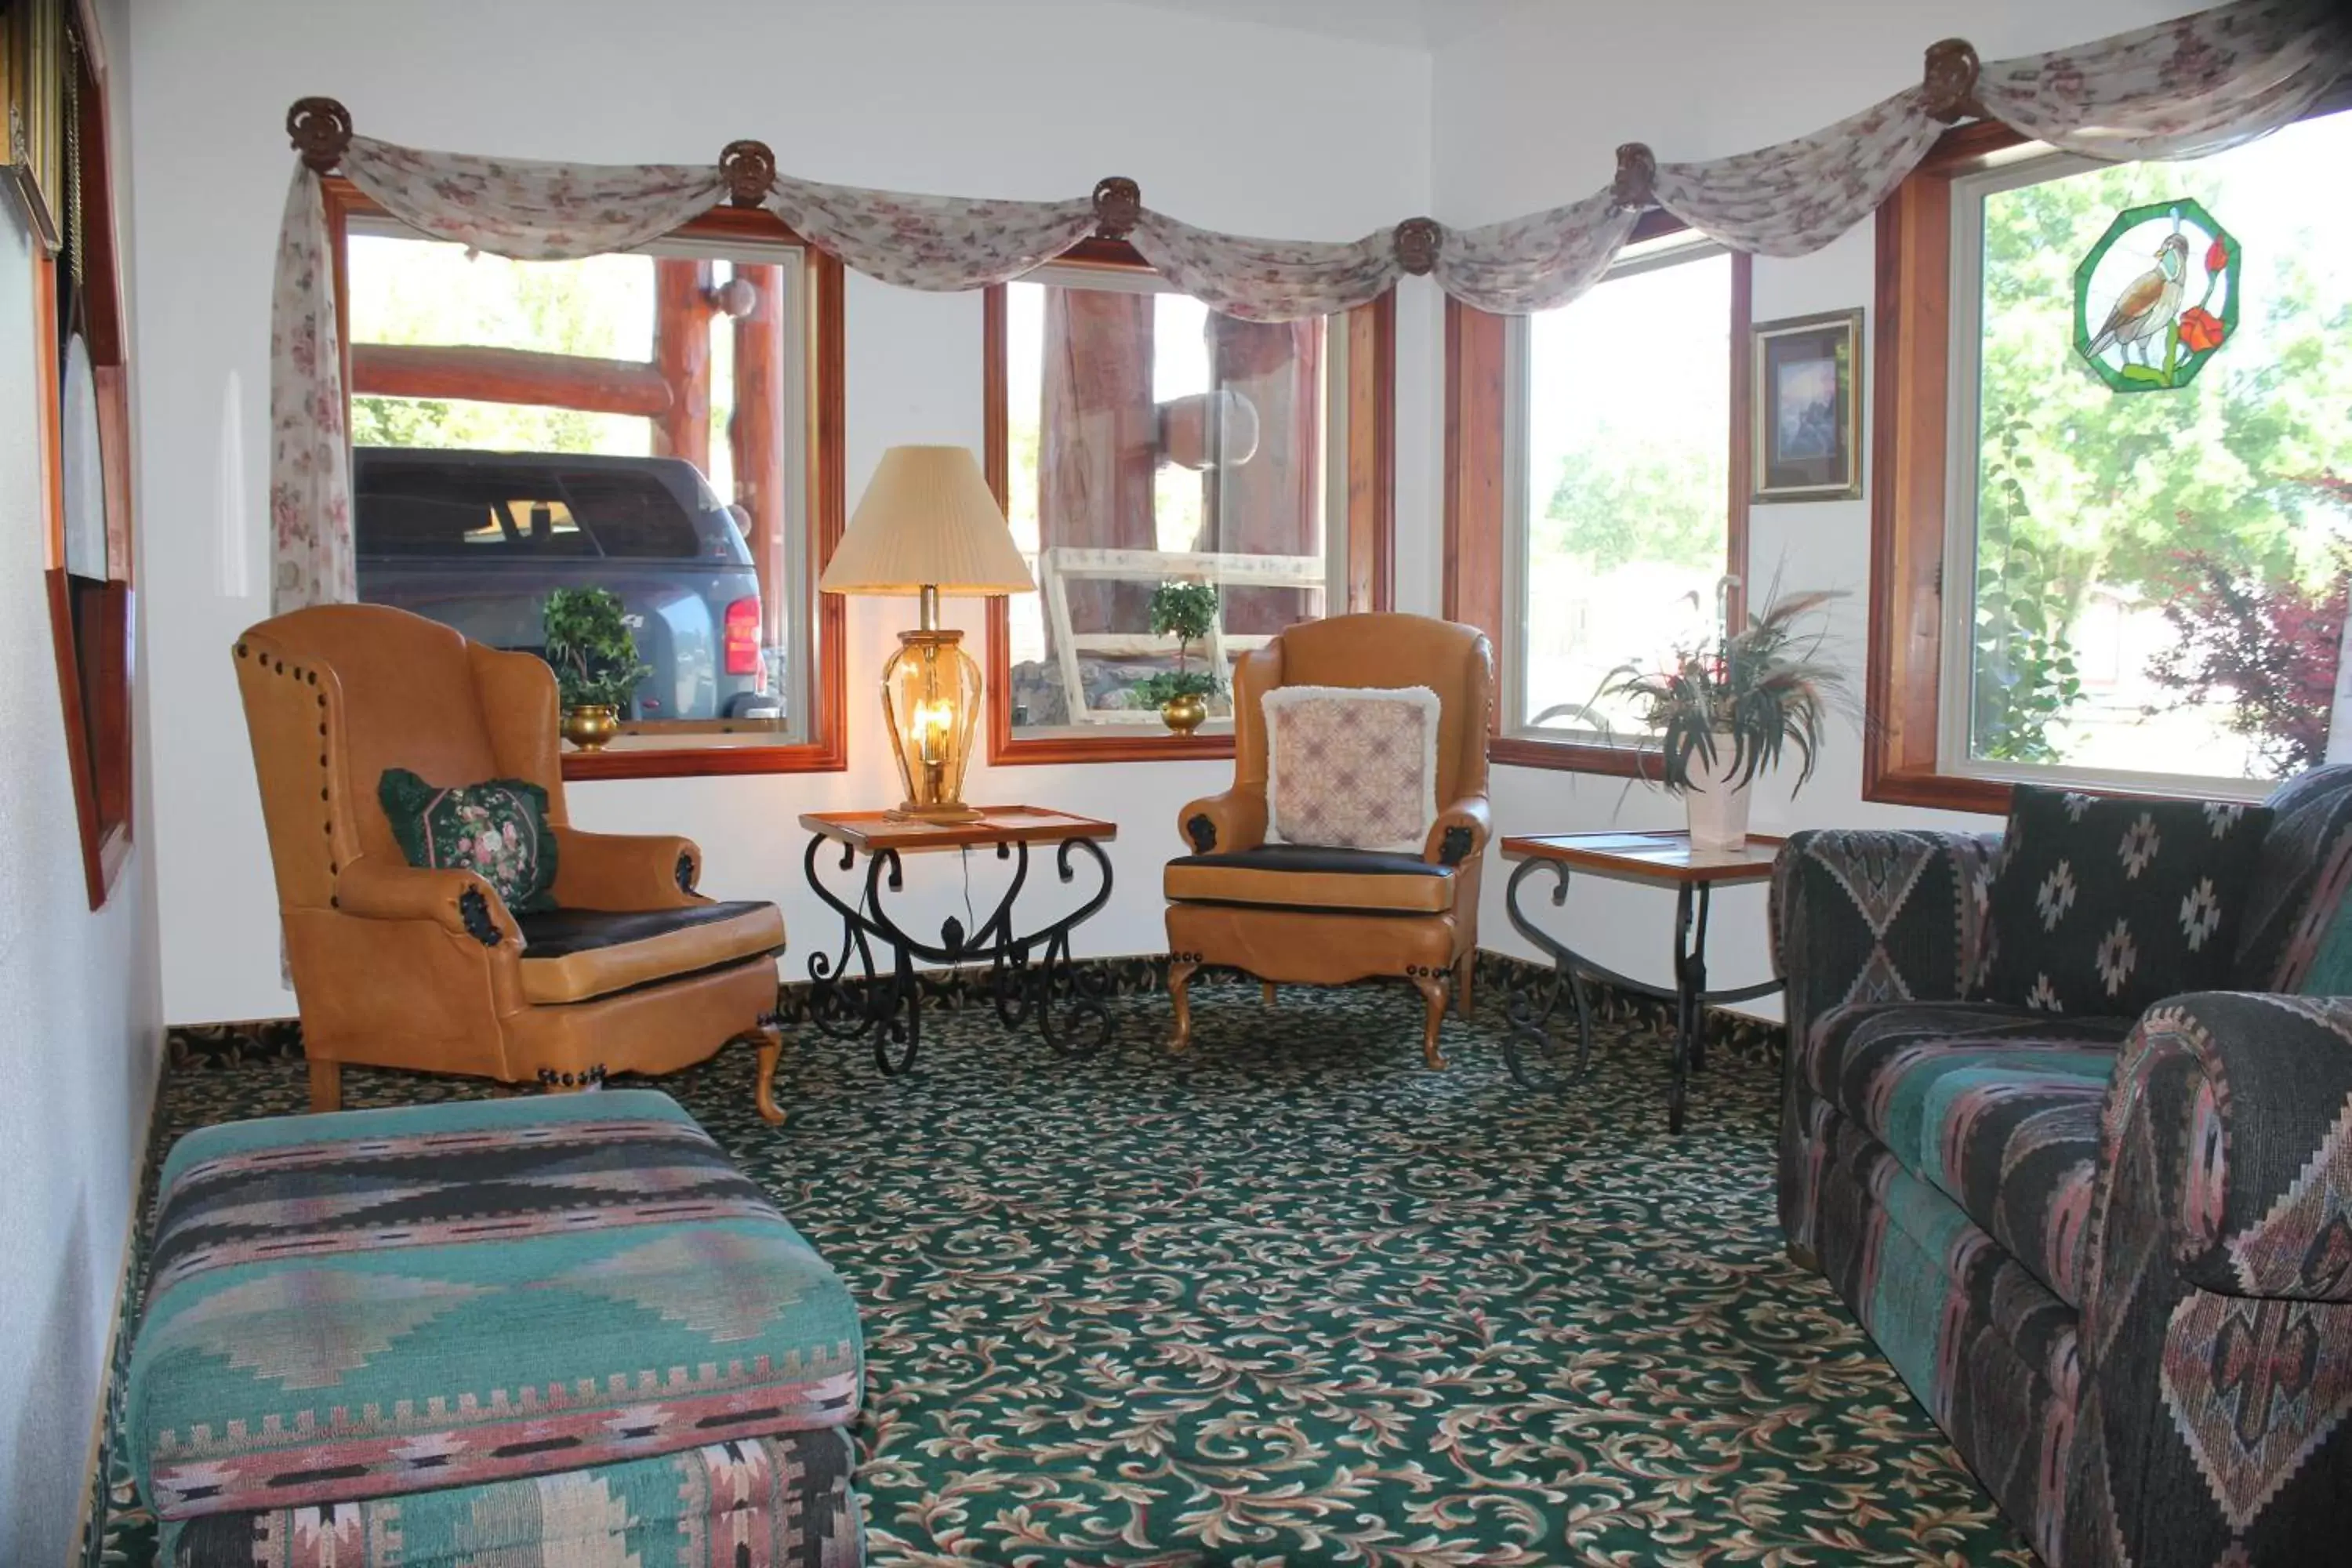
[{"xmin": 1750, "ymin": 310, "xmax": 1863, "ymax": 501}]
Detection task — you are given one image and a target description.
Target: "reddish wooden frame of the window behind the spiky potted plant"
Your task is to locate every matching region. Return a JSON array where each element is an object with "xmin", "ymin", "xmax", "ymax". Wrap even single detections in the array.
[{"xmin": 1442, "ymin": 209, "xmax": 1755, "ymax": 779}]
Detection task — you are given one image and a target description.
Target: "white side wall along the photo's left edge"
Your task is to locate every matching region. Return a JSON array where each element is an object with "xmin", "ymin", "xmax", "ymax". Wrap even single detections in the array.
[{"xmin": 0, "ymin": 7, "xmax": 162, "ymax": 1563}]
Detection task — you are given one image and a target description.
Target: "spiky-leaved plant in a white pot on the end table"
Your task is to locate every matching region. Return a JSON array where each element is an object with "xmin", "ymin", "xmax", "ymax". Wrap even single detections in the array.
[{"xmin": 1595, "ymin": 579, "xmax": 1846, "ymax": 848}]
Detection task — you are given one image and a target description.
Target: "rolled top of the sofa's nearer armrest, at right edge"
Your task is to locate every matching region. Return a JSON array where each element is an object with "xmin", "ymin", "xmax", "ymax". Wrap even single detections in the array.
[{"xmin": 2091, "ymin": 992, "xmax": 2352, "ymax": 1305}]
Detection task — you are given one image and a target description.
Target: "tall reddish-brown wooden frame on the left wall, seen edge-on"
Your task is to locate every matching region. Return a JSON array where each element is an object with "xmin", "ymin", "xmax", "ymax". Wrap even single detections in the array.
[{"xmin": 33, "ymin": 7, "xmax": 136, "ymax": 909}]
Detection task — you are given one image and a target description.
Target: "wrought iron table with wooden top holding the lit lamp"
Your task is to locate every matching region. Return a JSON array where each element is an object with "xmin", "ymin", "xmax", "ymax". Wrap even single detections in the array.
[{"xmin": 795, "ymin": 806, "xmax": 1120, "ymax": 1081}]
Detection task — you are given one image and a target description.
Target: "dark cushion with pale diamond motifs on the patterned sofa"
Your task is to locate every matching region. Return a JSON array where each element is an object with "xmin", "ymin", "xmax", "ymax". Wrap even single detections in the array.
[{"xmin": 1985, "ymin": 785, "xmax": 2270, "ymax": 1018}]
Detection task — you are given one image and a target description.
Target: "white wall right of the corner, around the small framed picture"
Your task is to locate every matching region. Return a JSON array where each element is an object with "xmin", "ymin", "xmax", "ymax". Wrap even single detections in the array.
[{"xmin": 1430, "ymin": 0, "xmax": 2197, "ymax": 1015}]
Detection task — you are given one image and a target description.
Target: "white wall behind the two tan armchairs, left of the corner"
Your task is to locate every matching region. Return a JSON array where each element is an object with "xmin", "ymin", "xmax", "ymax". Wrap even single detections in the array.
[{"xmin": 132, "ymin": 0, "xmax": 1439, "ymax": 1022}]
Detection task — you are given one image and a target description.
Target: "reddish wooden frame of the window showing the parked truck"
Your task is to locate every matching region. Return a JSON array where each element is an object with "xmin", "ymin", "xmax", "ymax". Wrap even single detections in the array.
[{"xmin": 320, "ymin": 174, "xmax": 849, "ymax": 783}]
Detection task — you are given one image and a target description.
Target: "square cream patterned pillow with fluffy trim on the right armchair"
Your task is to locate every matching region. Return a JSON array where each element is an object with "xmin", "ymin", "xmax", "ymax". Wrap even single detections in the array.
[{"xmin": 1263, "ymin": 687, "xmax": 1437, "ymax": 853}]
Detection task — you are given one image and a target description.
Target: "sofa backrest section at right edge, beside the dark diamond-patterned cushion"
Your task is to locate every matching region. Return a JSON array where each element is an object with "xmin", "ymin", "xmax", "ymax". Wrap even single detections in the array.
[{"xmin": 2230, "ymin": 767, "xmax": 2352, "ymax": 992}]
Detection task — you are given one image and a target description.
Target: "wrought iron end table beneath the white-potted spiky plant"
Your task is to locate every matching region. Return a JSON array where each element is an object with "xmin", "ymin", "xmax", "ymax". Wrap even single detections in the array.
[{"xmin": 1503, "ymin": 832, "xmax": 1780, "ymax": 1133}]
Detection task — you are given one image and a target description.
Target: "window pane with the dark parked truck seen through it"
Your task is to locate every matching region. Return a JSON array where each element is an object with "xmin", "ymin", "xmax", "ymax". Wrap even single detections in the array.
[{"xmin": 348, "ymin": 233, "xmax": 814, "ymax": 746}]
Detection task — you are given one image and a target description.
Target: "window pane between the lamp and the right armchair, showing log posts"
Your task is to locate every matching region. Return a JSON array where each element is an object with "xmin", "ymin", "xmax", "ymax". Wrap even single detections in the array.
[{"xmin": 1004, "ymin": 282, "xmax": 1329, "ymax": 734}]
